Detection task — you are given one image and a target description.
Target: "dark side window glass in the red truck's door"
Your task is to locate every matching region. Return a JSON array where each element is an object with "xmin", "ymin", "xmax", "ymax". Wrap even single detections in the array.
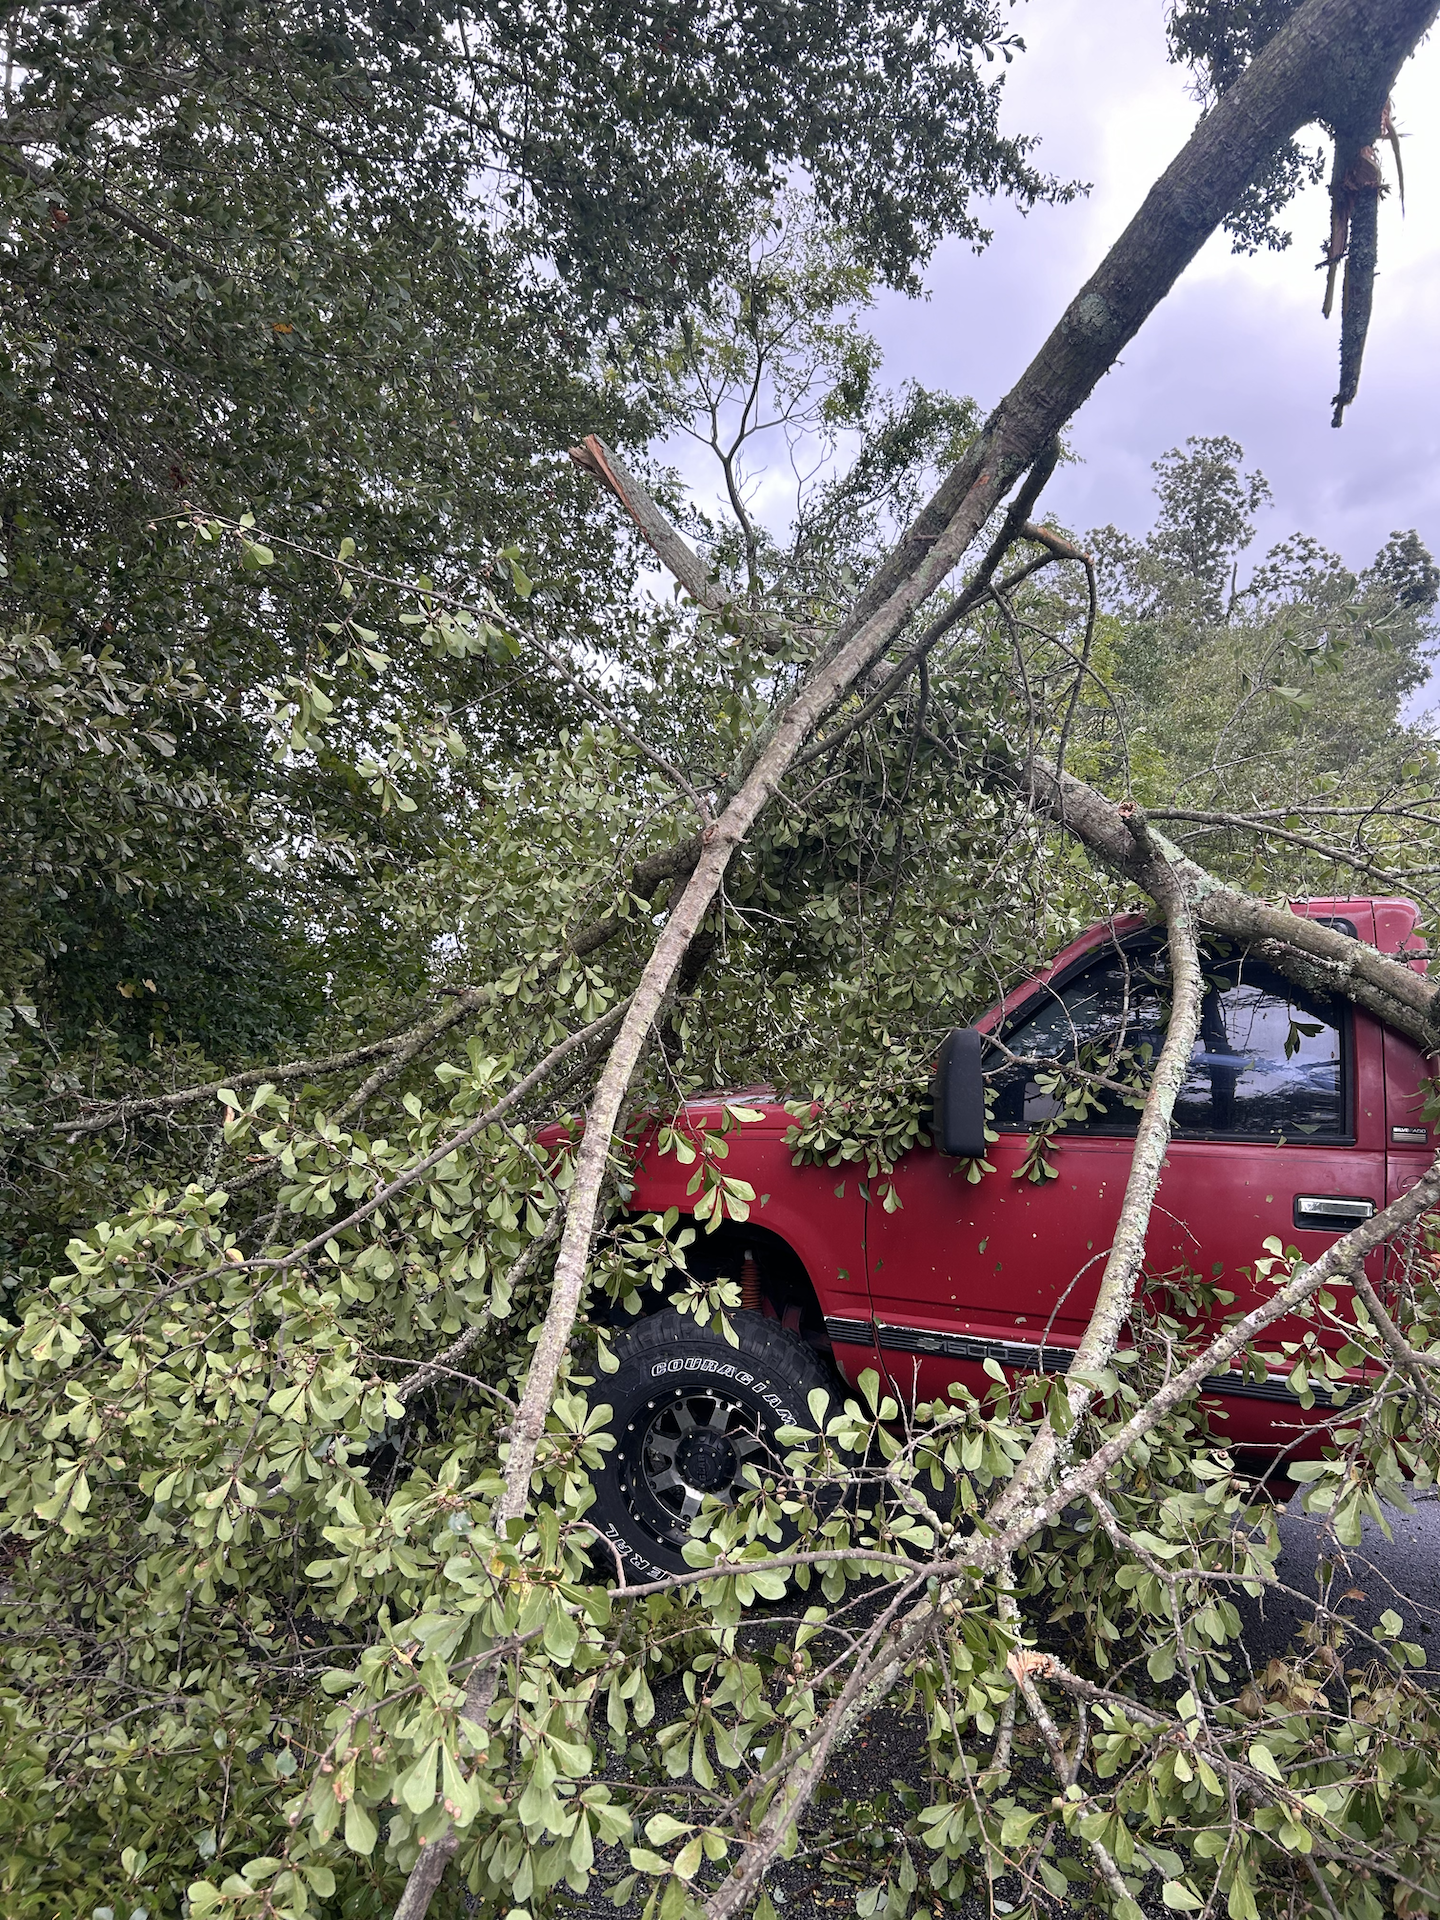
[{"xmin": 989, "ymin": 945, "xmax": 1346, "ymax": 1140}]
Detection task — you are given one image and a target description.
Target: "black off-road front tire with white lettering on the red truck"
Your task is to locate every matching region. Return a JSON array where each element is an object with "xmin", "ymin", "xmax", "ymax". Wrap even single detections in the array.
[{"xmin": 586, "ymin": 1311, "xmax": 843, "ymax": 1586}]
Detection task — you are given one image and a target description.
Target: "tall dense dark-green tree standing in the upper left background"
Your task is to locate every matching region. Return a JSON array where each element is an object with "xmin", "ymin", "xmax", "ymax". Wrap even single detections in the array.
[{"xmin": 0, "ymin": 0, "xmax": 1062, "ymax": 1263}]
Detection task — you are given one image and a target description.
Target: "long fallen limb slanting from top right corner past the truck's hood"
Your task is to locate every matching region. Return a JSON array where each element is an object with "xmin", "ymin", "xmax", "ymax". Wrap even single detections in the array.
[{"xmin": 396, "ymin": 0, "xmax": 1440, "ymax": 1920}]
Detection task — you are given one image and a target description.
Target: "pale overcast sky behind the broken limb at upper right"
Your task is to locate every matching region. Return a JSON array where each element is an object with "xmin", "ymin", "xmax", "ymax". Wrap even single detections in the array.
[{"xmin": 874, "ymin": 0, "xmax": 1440, "ymax": 566}]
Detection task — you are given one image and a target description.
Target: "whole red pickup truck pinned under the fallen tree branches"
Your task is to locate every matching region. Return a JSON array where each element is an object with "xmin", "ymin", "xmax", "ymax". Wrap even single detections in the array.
[{"xmin": 593, "ymin": 899, "xmax": 1434, "ymax": 1578}]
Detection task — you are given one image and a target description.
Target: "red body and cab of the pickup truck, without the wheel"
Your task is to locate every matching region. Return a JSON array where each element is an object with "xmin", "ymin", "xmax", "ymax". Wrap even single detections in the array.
[{"xmin": 630, "ymin": 899, "xmax": 1434, "ymax": 1457}]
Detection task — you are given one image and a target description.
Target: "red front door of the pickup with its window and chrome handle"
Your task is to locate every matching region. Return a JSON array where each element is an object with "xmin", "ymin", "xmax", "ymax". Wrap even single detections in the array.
[{"xmin": 868, "ymin": 937, "xmax": 1384, "ymax": 1444}]
